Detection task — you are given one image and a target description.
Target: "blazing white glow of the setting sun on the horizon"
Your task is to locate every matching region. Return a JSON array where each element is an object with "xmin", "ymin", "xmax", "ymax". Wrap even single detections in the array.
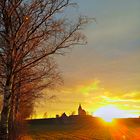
[{"xmin": 94, "ymin": 105, "xmax": 127, "ymax": 122}]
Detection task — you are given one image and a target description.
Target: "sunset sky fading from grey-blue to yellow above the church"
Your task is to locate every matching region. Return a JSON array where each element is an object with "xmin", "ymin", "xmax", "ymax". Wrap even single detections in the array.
[{"xmin": 36, "ymin": 0, "xmax": 140, "ymax": 117}]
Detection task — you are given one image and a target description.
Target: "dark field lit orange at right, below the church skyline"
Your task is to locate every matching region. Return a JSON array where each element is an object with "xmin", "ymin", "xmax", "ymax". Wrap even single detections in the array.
[{"xmin": 25, "ymin": 116, "xmax": 140, "ymax": 140}]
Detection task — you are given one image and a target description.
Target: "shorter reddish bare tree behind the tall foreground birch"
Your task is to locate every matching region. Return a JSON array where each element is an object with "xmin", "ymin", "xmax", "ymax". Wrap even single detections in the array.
[{"xmin": 8, "ymin": 59, "xmax": 61, "ymax": 140}]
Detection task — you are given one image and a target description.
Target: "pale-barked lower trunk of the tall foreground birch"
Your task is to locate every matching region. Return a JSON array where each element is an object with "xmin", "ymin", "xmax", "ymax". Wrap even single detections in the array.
[{"xmin": 0, "ymin": 80, "xmax": 12, "ymax": 140}]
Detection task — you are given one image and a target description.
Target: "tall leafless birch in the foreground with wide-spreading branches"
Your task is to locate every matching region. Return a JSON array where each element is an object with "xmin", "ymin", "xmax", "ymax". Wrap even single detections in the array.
[{"xmin": 0, "ymin": 0, "xmax": 88, "ymax": 140}]
